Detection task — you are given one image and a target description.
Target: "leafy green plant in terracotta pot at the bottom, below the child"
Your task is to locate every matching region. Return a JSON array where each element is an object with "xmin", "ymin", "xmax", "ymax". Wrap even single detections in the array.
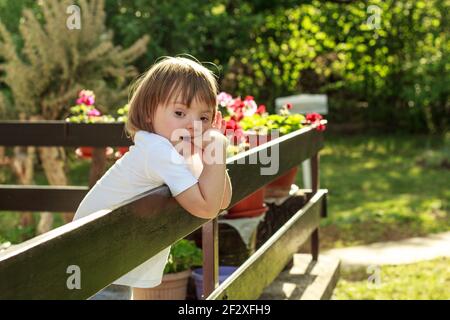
[{"xmin": 133, "ymin": 239, "xmax": 203, "ymax": 300}]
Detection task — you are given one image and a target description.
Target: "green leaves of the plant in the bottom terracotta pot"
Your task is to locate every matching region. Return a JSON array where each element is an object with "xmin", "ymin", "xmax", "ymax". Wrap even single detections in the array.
[{"xmin": 164, "ymin": 239, "xmax": 203, "ymax": 274}]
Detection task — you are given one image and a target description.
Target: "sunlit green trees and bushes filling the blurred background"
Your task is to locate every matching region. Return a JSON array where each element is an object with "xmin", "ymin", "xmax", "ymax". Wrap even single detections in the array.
[{"xmin": 0, "ymin": 0, "xmax": 450, "ymax": 133}]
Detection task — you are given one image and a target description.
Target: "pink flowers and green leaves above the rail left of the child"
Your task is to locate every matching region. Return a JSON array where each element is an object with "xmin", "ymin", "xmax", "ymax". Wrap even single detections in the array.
[{"xmin": 66, "ymin": 90, "xmax": 115, "ymax": 123}]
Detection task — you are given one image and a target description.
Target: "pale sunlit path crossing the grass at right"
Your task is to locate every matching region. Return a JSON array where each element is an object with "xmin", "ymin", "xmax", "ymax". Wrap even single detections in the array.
[{"xmin": 321, "ymin": 231, "xmax": 450, "ymax": 267}]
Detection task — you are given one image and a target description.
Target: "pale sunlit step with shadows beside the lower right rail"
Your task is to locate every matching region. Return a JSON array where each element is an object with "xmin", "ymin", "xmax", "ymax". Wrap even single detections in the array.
[{"xmin": 259, "ymin": 254, "xmax": 340, "ymax": 300}]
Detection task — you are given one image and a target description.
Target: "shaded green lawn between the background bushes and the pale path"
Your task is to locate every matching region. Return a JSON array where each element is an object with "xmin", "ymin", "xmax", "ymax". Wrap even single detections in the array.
[{"xmin": 297, "ymin": 135, "xmax": 450, "ymax": 249}]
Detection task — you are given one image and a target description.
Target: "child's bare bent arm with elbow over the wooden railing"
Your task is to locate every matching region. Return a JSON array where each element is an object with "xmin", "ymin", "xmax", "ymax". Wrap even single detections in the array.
[{"xmin": 175, "ymin": 132, "xmax": 231, "ymax": 219}]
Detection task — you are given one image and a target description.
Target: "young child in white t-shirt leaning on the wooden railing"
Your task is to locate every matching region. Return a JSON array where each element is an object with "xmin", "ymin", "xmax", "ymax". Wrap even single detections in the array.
[{"xmin": 74, "ymin": 57, "xmax": 232, "ymax": 300}]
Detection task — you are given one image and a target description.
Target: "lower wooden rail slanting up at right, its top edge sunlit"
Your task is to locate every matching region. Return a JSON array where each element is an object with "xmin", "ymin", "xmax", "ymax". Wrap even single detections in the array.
[{"xmin": 208, "ymin": 189, "xmax": 327, "ymax": 300}]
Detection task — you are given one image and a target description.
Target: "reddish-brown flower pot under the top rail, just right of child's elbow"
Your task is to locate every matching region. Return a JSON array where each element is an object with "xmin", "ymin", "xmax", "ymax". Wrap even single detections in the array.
[{"xmin": 224, "ymin": 187, "xmax": 268, "ymax": 219}]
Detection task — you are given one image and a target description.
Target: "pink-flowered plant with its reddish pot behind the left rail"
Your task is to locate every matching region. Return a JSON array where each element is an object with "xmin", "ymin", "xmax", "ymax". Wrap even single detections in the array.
[{"xmin": 66, "ymin": 90, "xmax": 115, "ymax": 159}]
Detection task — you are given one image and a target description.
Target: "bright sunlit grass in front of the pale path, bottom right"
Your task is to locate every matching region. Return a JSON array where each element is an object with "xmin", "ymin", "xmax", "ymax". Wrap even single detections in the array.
[{"xmin": 333, "ymin": 258, "xmax": 450, "ymax": 300}]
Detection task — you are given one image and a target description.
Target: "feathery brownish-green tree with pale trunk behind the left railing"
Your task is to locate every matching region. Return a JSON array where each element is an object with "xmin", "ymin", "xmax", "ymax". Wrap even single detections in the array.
[{"xmin": 0, "ymin": 0, "xmax": 148, "ymax": 232}]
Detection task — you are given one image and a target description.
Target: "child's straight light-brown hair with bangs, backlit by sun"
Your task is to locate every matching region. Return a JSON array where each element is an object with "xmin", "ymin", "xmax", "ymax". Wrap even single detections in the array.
[{"xmin": 125, "ymin": 57, "xmax": 218, "ymax": 140}]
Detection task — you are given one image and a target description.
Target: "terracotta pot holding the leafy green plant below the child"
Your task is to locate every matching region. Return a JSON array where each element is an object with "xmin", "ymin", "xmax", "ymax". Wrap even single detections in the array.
[{"xmin": 133, "ymin": 270, "xmax": 191, "ymax": 300}]
